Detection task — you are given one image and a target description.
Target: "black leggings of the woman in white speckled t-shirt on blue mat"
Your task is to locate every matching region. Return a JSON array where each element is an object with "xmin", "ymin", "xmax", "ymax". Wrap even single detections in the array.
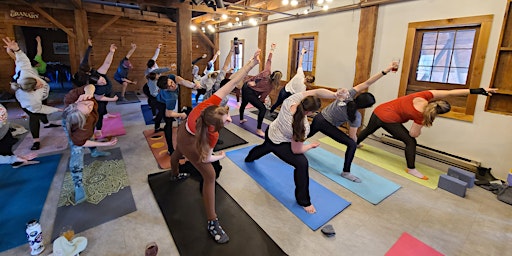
[{"xmin": 245, "ymin": 129, "xmax": 311, "ymax": 207}]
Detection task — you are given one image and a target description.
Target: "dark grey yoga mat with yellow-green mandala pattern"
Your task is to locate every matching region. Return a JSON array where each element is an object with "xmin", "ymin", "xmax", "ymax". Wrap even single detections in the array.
[{"xmin": 52, "ymin": 148, "xmax": 137, "ymax": 241}]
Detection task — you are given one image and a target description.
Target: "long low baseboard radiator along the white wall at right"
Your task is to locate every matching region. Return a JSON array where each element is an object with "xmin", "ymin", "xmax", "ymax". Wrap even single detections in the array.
[{"xmin": 380, "ymin": 133, "xmax": 481, "ymax": 172}]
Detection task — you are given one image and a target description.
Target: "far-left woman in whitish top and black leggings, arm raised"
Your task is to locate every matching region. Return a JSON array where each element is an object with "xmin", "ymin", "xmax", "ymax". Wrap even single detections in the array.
[{"xmin": 2, "ymin": 37, "xmax": 61, "ymax": 150}]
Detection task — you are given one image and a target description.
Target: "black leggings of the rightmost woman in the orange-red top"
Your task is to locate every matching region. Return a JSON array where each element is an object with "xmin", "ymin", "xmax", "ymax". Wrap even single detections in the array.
[{"xmin": 357, "ymin": 114, "xmax": 416, "ymax": 169}]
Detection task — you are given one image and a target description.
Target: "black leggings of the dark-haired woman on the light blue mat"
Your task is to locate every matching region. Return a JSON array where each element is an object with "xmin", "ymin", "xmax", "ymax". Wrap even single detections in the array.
[{"xmin": 308, "ymin": 113, "xmax": 357, "ymax": 172}]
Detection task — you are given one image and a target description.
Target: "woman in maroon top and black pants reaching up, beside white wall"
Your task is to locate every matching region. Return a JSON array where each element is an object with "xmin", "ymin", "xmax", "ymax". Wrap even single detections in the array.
[{"xmin": 240, "ymin": 43, "xmax": 283, "ymax": 137}]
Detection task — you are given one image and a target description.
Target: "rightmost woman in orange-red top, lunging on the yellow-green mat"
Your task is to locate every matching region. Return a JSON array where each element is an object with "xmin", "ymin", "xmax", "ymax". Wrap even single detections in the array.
[{"xmin": 357, "ymin": 88, "xmax": 496, "ymax": 180}]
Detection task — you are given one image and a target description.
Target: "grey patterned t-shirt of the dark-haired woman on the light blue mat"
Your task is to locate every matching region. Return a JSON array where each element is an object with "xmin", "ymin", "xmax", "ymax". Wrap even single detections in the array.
[{"xmin": 322, "ymin": 89, "xmax": 361, "ymax": 127}]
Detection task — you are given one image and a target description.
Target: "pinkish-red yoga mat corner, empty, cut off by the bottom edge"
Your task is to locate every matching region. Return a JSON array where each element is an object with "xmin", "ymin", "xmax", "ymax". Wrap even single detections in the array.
[{"xmin": 385, "ymin": 232, "xmax": 444, "ymax": 256}]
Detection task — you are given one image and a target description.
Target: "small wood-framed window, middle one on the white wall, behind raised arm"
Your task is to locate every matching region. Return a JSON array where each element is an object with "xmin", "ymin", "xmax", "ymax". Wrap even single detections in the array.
[{"xmin": 288, "ymin": 32, "xmax": 318, "ymax": 80}]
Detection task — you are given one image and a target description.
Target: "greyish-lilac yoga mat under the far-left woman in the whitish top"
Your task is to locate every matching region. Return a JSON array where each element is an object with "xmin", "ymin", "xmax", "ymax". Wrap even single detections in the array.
[{"xmin": 14, "ymin": 124, "xmax": 68, "ymax": 155}]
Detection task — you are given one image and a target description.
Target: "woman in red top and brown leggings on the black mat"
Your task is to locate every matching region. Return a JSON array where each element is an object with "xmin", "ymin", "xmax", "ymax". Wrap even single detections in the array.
[{"xmin": 170, "ymin": 50, "xmax": 260, "ymax": 244}]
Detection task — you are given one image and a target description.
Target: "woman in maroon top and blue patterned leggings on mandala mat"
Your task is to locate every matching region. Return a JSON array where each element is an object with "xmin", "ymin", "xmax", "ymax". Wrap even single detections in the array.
[{"xmin": 62, "ymin": 84, "xmax": 117, "ymax": 204}]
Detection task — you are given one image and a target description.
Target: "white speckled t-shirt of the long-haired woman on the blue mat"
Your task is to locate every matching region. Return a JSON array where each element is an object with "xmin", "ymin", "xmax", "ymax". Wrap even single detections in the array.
[{"xmin": 268, "ymin": 93, "xmax": 309, "ymax": 144}]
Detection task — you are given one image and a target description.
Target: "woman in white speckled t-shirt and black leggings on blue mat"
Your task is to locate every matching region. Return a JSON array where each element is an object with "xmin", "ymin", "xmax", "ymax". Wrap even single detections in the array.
[{"xmin": 245, "ymin": 89, "xmax": 346, "ymax": 214}]
